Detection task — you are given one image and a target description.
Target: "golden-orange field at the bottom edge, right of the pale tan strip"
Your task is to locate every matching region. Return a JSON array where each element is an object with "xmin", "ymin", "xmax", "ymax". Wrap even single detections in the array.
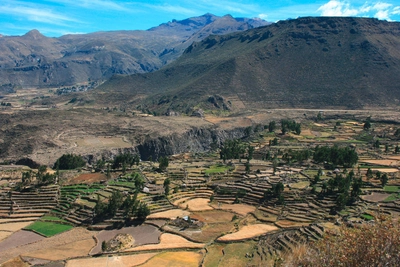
[{"xmin": 141, "ymin": 251, "xmax": 202, "ymax": 267}]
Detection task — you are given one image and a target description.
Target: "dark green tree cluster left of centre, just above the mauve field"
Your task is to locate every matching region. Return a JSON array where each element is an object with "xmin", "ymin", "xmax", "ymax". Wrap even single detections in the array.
[{"xmin": 94, "ymin": 190, "xmax": 150, "ymax": 221}]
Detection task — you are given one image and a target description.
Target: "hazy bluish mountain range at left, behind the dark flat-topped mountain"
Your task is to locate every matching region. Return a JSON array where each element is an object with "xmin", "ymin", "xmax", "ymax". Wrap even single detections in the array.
[{"xmin": 0, "ymin": 14, "xmax": 268, "ymax": 91}]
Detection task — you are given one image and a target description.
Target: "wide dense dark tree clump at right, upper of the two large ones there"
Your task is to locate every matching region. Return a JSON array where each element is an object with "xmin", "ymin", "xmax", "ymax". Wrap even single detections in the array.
[{"xmin": 313, "ymin": 145, "xmax": 358, "ymax": 168}]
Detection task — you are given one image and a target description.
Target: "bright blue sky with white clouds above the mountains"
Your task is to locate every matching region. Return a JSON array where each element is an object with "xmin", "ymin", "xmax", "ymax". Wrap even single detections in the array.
[{"xmin": 0, "ymin": 0, "xmax": 400, "ymax": 36}]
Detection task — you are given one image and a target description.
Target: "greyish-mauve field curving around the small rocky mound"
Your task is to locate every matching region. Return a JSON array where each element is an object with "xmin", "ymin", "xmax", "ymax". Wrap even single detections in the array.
[{"xmin": 90, "ymin": 224, "xmax": 161, "ymax": 254}]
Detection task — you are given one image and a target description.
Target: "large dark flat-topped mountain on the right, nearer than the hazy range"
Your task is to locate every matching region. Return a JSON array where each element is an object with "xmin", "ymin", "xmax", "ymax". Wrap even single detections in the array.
[{"xmin": 96, "ymin": 17, "xmax": 400, "ymax": 114}]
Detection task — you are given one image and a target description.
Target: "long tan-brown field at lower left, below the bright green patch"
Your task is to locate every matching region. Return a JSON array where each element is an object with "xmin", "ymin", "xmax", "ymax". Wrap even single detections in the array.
[{"xmin": 0, "ymin": 227, "xmax": 96, "ymax": 263}]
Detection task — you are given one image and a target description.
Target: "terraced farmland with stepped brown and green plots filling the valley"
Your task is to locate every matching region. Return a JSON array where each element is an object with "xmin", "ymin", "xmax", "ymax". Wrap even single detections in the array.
[{"xmin": 0, "ymin": 114, "xmax": 400, "ymax": 266}]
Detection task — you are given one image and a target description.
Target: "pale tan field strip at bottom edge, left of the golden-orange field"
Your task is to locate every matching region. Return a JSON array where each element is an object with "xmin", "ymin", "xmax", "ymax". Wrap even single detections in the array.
[{"xmin": 65, "ymin": 253, "xmax": 158, "ymax": 267}]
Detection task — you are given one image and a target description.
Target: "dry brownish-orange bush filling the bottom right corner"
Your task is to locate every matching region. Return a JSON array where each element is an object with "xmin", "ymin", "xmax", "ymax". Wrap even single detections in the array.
[{"xmin": 281, "ymin": 216, "xmax": 400, "ymax": 267}]
